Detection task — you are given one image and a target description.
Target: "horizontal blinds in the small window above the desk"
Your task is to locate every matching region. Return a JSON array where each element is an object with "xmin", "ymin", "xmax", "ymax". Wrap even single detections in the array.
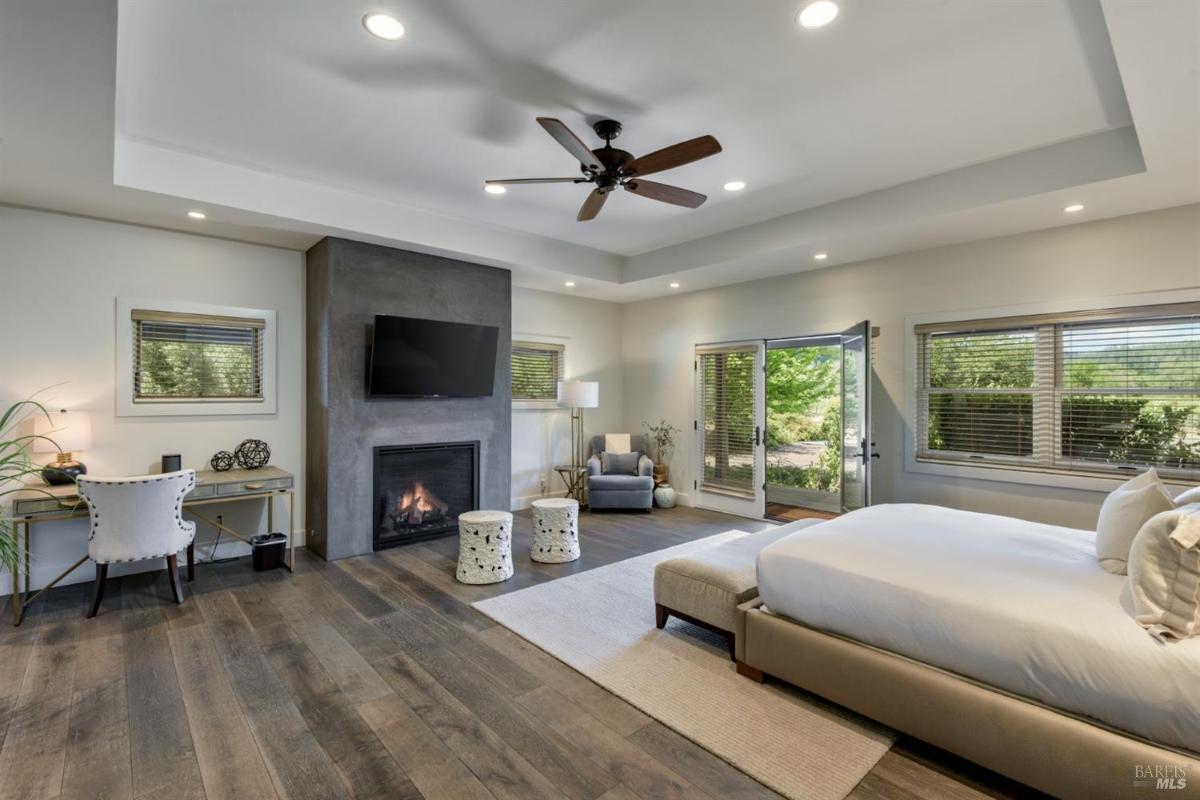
[{"xmin": 132, "ymin": 309, "xmax": 266, "ymax": 402}]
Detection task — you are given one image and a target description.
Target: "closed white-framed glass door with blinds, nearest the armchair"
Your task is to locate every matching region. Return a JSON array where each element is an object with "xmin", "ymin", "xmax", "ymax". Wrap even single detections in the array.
[{"xmin": 694, "ymin": 341, "xmax": 767, "ymax": 517}]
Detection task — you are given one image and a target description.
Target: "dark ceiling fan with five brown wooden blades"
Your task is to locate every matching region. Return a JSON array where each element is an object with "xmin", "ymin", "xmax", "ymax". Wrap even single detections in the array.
[{"xmin": 484, "ymin": 116, "xmax": 721, "ymax": 222}]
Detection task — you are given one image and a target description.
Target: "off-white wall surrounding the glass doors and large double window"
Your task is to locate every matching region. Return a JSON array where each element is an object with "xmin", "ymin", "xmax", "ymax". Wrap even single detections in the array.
[{"xmin": 620, "ymin": 205, "xmax": 1200, "ymax": 528}]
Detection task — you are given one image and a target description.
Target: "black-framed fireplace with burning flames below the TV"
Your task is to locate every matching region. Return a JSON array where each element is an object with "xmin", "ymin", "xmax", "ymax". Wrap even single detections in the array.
[{"xmin": 372, "ymin": 441, "xmax": 479, "ymax": 551}]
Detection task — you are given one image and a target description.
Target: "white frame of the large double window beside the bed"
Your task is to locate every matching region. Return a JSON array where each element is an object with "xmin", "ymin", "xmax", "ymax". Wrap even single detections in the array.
[{"xmin": 904, "ymin": 289, "xmax": 1200, "ymax": 492}]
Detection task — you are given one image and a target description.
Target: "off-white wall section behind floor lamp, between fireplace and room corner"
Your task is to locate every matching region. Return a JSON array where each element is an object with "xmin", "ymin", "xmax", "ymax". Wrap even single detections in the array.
[{"xmin": 512, "ymin": 288, "xmax": 624, "ymax": 509}]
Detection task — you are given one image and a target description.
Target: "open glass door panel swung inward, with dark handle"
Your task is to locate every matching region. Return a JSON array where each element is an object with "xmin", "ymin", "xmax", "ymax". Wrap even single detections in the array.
[{"xmin": 841, "ymin": 321, "xmax": 875, "ymax": 512}]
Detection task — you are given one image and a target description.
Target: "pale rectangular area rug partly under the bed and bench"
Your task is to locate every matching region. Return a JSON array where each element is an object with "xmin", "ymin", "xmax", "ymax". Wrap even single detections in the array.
[{"xmin": 474, "ymin": 531, "xmax": 894, "ymax": 800}]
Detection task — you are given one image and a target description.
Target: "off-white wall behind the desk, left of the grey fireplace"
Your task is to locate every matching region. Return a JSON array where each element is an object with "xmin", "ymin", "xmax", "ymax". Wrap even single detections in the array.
[{"xmin": 0, "ymin": 207, "xmax": 305, "ymax": 594}]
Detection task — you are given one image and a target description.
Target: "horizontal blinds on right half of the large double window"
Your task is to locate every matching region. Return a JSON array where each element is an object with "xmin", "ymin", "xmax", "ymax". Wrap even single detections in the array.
[{"xmin": 1056, "ymin": 314, "xmax": 1200, "ymax": 479}]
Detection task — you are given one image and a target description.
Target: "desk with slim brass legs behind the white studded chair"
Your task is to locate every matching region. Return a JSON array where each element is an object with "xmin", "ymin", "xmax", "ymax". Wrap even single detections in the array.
[{"xmin": 12, "ymin": 467, "xmax": 296, "ymax": 625}]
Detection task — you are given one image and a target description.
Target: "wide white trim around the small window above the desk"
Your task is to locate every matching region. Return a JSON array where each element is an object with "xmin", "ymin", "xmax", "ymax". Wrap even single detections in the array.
[{"xmin": 114, "ymin": 297, "xmax": 278, "ymax": 416}]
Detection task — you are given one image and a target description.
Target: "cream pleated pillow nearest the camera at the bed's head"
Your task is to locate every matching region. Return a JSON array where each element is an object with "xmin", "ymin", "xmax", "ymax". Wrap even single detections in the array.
[{"xmin": 1129, "ymin": 503, "xmax": 1200, "ymax": 640}]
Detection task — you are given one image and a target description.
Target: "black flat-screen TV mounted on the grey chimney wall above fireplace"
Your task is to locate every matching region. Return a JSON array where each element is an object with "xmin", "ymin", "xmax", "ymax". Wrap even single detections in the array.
[{"xmin": 367, "ymin": 314, "xmax": 499, "ymax": 397}]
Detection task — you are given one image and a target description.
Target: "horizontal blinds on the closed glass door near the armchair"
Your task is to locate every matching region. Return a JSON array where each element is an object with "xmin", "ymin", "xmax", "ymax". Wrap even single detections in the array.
[{"xmin": 696, "ymin": 347, "xmax": 757, "ymax": 495}]
